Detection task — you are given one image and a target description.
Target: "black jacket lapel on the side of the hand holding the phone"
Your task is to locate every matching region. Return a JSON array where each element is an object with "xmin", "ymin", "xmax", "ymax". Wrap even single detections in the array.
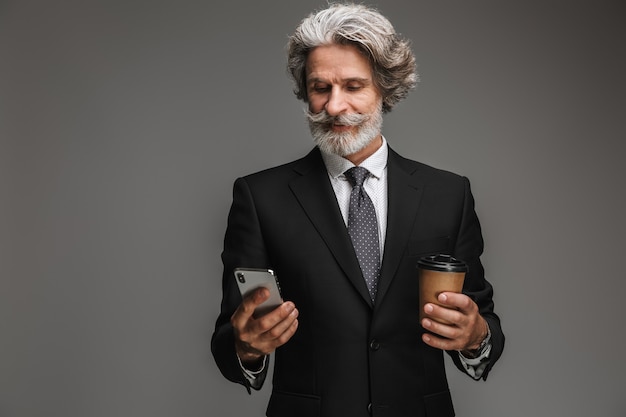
[{"xmin": 289, "ymin": 148, "xmax": 371, "ymax": 305}]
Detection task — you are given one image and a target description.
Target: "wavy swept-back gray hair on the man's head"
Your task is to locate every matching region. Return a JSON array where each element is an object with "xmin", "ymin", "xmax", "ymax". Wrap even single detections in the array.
[{"xmin": 287, "ymin": 4, "xmax": 418, "ymax": 112}]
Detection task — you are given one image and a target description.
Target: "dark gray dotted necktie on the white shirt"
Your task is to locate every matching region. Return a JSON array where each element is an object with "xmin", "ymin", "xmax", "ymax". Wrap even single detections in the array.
[{"xmin": 344, "ymin": 167, "xmax": 380, "ymax": 301}]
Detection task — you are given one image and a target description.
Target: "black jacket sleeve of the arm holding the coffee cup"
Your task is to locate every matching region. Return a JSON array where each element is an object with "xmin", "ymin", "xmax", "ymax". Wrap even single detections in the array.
[{"xmin": 449, "ymin": 178, "xmax": 504, "ymax": 380}]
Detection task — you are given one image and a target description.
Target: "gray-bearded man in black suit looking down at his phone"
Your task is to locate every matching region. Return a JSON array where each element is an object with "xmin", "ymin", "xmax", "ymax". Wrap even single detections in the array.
[{"xmin": 212, "ymin": 5, "xmax": 504, "ymax": 417}]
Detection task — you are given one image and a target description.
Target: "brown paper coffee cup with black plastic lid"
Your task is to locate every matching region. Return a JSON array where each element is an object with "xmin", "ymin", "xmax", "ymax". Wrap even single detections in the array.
[{"xmin": 417, "ymin": 255, "xmax": 468, "ymax": 324}]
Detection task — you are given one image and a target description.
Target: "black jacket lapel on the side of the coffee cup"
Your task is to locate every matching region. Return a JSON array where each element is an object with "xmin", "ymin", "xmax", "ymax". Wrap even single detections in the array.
[{"xmin": 376, "ymin": 148, "xmax": 423, "ymax": 305}]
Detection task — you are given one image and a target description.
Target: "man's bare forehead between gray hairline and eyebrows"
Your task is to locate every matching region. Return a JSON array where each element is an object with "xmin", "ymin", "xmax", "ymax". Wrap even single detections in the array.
[{"xmin": 306, "ymin": 44, "xmax": 372, "ymax": 81}]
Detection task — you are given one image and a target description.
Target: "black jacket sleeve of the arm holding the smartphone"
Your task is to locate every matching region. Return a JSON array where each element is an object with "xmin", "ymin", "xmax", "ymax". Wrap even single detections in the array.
[{"xmin": 211, "ymin": 178, "xmax": 269, "ymax": 393}]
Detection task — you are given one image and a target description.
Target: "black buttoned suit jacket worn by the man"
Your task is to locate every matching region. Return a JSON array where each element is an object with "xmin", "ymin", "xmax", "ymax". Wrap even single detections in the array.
[{"xmin": 212, "ymin": 149, "xmax": 504, "ymax": 417}]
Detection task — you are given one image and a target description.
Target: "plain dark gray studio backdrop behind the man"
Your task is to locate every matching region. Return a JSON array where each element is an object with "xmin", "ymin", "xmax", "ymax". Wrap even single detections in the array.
[{"xmin": 0, "ymin": 0, "xmax": 626, "ymax": 417}]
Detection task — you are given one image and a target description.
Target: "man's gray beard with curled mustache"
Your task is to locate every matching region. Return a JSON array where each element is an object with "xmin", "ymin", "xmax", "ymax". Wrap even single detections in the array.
[{"xmin": 306, "ymin": 105, "xmax": 383, "ymax": 157}]
